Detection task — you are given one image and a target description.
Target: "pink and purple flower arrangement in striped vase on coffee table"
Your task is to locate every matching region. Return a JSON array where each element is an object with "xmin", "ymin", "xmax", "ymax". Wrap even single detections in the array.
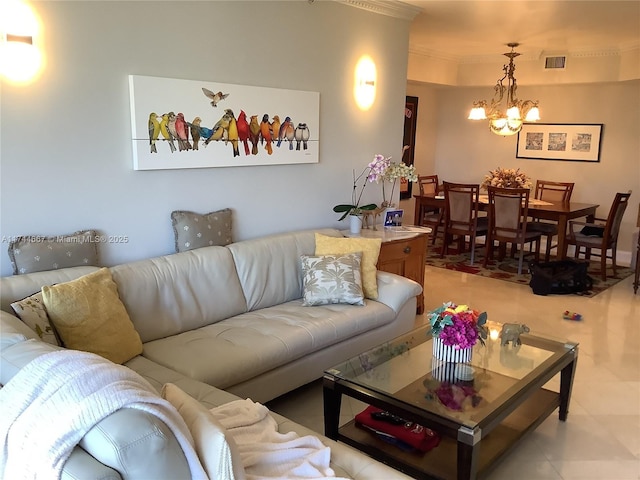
[{"xmin": 427, "ymin": 302, "xmax": 488, "ymax": 363}]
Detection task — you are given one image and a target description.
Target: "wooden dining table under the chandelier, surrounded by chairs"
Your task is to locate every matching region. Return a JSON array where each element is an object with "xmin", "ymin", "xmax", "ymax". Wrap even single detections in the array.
[{"xmin": 413, "ymin": 195, "xmax": 600, "ymax": 260}]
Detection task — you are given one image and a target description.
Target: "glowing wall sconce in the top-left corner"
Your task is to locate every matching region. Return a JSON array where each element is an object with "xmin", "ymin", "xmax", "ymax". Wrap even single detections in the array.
[{"xmin": 0, "ymin": 1, "xmax": 43, "ymax": 83}]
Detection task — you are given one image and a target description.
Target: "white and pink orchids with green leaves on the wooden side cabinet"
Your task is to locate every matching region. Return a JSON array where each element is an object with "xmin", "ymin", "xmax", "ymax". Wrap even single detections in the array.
[{"xmin": 333, "ymin": 154, "xmax": 418, "ymax": 220}]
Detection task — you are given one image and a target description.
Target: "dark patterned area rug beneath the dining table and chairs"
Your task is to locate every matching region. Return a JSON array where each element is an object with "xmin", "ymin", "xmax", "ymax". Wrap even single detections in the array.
[{"xmin": 426, "ymin": 243, "xmax": 633, "ymax": 297}]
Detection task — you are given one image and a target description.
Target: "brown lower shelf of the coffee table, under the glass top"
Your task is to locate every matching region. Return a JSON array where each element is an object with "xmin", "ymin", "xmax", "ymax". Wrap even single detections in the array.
[{"xmin": 338, "ymin": 389, "xmax": 560, "ymax": 479}]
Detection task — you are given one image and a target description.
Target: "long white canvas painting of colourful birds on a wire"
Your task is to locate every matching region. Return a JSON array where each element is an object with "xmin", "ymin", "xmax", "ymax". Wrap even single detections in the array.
[{"xmin": 129, "ymin": 75, "xmax": 320, "ymax": 170}]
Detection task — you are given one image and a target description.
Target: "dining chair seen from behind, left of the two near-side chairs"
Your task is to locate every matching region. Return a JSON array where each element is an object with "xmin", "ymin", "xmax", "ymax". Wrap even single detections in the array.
[{"xmin": 440, "ymin": 182, "xmax": 489, "ymax": 265}]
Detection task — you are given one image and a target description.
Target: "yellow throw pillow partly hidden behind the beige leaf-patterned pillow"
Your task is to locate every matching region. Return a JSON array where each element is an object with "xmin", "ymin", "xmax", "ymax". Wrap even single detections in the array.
[{"xmin": 315, "ymin": 233, "xmax": 382, "ymax": 300}]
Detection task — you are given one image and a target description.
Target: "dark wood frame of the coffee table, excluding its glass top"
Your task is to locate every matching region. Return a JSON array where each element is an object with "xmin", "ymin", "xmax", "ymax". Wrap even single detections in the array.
[{"xmin": 323, "ymin": 327, "xmax": 578, "ymax": 480}]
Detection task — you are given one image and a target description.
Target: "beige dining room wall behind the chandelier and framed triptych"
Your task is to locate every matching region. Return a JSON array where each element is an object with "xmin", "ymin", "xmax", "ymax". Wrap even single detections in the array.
[{"xmin": 404, "ymin": 80, "xmax": 640, "ymax": 261}]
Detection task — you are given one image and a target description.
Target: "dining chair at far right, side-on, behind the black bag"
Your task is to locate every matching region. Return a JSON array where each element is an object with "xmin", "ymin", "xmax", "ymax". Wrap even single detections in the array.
[{"xmin": 567, "ymin": 190, "xmax": 631, "ymax": 281}]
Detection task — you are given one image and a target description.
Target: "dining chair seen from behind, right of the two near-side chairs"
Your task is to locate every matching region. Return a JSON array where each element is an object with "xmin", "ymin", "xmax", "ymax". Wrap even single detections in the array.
[{"xmin": 483, "ymin": 186, "xmax": 542, "ymax": 275}]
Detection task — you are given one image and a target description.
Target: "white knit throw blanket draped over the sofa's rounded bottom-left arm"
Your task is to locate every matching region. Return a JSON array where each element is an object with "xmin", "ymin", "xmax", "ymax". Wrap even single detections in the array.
[{"xmin": 0, "ymin": 350, "xmax": 207, "ymax": 480}]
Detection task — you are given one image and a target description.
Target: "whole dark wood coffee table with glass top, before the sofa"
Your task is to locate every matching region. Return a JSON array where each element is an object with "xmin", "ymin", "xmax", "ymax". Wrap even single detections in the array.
[{"xmin": 323, "ymin": 322, "xmax": 578, "ymax": 479}]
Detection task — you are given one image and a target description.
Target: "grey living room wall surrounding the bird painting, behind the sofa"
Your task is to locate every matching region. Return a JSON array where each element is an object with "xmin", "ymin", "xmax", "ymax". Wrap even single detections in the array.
[{"xmin": 0, "ymin": 1, "xmax": 409, "ymax": 275}]
